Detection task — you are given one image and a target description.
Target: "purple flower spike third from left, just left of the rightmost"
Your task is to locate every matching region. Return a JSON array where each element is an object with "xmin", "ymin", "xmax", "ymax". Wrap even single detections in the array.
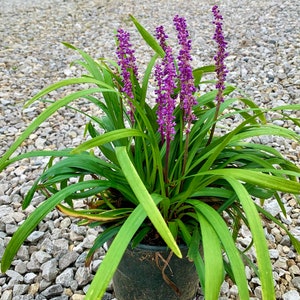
[{"xmin": 174, "ymin": 15, "xmax": 197, "ymax": 133}]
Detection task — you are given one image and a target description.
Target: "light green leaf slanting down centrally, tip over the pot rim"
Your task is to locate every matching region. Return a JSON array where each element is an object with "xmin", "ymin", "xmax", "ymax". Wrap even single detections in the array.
[{"xmin": 116, "ymin": 147, "xmax": 182, "ymax": 257}]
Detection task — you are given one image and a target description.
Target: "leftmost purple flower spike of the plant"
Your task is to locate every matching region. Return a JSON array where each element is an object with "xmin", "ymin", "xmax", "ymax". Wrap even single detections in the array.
[{"xmin": 116, "ymin": 28, "xmax": 138, "ymax": 122}]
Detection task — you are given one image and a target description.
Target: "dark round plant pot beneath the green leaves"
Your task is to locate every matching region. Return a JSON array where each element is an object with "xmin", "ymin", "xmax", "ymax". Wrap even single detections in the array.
[{"xmin": 113, "ymin": 245, "xmax": 199, "ymax": 300}]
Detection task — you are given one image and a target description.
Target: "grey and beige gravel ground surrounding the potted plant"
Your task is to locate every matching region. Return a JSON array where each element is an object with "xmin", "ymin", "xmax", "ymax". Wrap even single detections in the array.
[{"xmin": 0, "ymin": 0, "xmax": 300, "ymax": 300}]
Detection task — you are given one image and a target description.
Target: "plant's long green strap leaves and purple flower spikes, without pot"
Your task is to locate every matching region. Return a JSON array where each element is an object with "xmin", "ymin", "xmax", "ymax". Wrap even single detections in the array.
[{"xmin": 0, "ymin": 6, "xmax": 300, "ymax": 300}]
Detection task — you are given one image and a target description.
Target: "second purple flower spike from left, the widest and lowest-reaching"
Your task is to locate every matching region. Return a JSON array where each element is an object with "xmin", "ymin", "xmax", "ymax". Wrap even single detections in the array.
[{"xmin": 154, "ymin": 26, "xmax": 176, "ymax": 146}]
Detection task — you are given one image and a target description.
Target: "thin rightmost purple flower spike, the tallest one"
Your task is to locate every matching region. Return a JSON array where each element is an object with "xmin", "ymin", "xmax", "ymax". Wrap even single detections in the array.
[{"xmin": 212, "ymin": 5, "xmax": 228, "ymax": 103}]
